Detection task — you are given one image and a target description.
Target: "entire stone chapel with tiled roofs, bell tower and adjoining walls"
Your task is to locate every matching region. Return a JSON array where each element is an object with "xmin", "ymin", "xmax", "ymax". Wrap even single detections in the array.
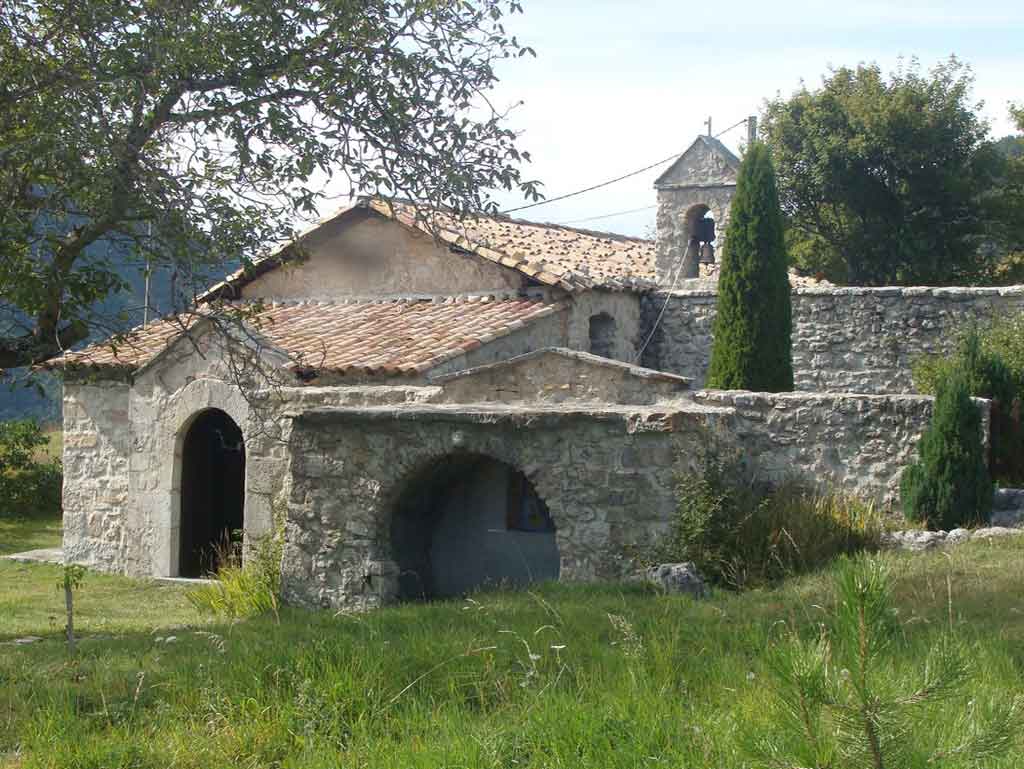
[{"xmin": 56, "ymin": 136, "xmax": 1024, "ymax": 609}]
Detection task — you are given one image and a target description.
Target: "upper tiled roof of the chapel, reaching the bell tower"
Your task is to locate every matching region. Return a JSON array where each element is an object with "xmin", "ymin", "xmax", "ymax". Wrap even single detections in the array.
[{"xmin": 200, "ymin": 199, "xmax": 655, "ymax": 301}]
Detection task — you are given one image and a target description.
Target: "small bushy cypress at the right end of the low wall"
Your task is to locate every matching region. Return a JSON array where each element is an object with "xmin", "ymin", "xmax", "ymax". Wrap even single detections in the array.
[{"xmin": 900, "ymin": 371, "xmax": 992, "ymax": 529}]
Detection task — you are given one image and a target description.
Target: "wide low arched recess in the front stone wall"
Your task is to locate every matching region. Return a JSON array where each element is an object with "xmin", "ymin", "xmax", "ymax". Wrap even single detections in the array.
[{"xmin": 391, "ymin": 454, "xmax": 559, "ymax": 599}]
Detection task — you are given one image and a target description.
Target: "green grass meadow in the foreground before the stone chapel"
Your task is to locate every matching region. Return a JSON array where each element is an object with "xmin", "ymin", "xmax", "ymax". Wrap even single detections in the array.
[{"xmin": 0, "ymin": 541, "xmax": 1024, "ymax": 769}]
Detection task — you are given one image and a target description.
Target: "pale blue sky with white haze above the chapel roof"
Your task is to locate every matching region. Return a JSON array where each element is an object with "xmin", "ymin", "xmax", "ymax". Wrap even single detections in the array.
[{"xmin": 485, "ymin": 0, "xmax": 1024, "ymax": 236}]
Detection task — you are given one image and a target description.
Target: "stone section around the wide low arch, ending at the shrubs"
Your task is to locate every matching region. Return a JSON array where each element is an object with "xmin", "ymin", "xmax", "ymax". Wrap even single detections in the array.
[{"xmin": 284, "ymin": 405, "xmax": 703, "ymax": 609}]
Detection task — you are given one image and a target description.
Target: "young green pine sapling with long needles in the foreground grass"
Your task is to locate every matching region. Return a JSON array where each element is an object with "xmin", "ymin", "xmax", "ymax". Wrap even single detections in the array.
[{"xmin": 746, "ymin": 558, "xmax": 1024, "ymax": 769}]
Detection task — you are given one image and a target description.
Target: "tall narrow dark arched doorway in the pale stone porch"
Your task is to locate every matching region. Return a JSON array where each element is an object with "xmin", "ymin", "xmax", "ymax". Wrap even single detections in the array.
[{"xmin": 178, "ymin": 409, "xmax": 246, "ymax": 576}]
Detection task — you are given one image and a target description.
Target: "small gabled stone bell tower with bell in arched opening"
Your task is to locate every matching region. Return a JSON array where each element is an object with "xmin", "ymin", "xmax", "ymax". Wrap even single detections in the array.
[{"xmin": 654, "ymin": 136, "xmax": 739, "ymax": 288}]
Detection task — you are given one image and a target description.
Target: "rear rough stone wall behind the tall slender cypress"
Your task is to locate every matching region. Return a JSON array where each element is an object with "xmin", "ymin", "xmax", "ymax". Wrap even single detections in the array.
[{"xmin": 642, "ymin": 286, "xmax": 1024, "ymax": 393}]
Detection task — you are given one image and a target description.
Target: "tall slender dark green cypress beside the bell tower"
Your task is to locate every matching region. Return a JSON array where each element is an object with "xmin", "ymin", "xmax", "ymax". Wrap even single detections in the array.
[{"xmin": 707, "ymin": 142, "xmax": 793, "ymax": 392}]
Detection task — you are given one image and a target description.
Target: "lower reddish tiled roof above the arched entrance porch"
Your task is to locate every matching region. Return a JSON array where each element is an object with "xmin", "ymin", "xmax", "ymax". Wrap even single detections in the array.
[{"xmin": 52, "ymin": 297, "xmax": 565, "ymax": 377}]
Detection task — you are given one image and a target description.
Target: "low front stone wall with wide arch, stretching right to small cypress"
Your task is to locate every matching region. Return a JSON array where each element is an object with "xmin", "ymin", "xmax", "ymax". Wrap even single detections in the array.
[{"xmin": 276, "ymin": 391, "xmax": 946, "ymax": 609}]
